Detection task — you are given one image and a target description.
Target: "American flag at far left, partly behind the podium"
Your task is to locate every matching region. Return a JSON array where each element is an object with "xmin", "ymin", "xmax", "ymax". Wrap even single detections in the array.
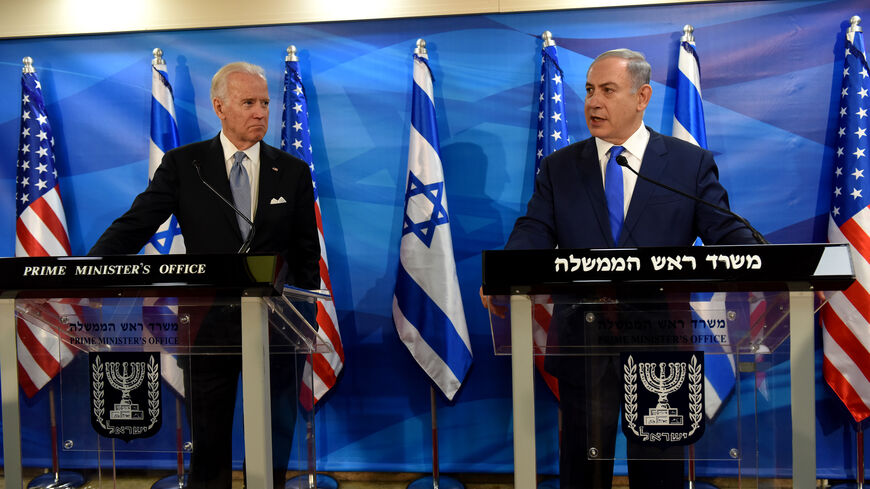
[{"xmin": 15, "ymin": 57, "xmax": 73, "ymax": 397}]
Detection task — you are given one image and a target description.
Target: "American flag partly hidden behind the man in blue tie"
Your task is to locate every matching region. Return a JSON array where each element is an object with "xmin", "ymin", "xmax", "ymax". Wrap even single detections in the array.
[{"xmin": 532, "ymin": 31, "xmax": 568, "ymax": 399}]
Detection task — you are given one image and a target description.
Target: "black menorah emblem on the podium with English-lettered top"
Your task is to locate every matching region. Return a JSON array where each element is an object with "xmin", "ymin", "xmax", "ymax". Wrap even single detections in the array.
[{"xmin": 88, "ymin": 352, "xmax": 163, "ymax": 441}]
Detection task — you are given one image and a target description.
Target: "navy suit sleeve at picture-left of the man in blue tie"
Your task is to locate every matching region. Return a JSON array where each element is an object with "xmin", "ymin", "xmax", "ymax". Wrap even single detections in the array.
[{"xmin": 505, "ymin": 156, "xmax": 557, "ymax": 250}]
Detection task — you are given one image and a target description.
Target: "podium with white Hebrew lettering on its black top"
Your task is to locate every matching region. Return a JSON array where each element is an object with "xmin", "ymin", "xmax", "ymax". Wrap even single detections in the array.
[{"xmin": 483, "ymin": 244, "xmax": 854, "ymax": 487}]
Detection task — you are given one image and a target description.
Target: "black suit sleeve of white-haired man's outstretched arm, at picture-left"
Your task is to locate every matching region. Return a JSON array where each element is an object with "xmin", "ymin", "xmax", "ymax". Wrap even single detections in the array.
[{"xmin": 88, "ymin": 152, "xmax": 178, "ymax": 256}]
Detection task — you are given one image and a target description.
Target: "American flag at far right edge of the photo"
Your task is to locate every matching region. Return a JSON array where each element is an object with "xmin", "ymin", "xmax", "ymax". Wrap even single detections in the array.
[{"xmin": 821, "ymin": 23, "xmax": 870, "ymax": 422}]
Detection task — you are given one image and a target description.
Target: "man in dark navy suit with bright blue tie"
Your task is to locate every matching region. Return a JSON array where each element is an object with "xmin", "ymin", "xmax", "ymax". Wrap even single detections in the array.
[{"xmin": 482, "ymin": 49, "xmax": 755, "ymax": 489}]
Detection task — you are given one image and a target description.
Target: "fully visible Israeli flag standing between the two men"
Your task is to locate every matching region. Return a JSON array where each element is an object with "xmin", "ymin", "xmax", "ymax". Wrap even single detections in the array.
[{"xmin": 393, "ymin": 41, "xmax": 471, "ymax": 400}]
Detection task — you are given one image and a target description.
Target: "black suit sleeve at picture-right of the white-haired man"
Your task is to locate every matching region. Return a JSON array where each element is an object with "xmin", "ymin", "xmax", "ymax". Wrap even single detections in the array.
[{"xmin": 287, "ymin": 166, "xmax": 320, "ymax": 289}]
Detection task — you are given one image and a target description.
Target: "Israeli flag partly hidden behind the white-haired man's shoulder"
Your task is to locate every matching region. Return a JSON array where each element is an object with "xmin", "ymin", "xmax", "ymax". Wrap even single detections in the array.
[{"xmin": 145, "ymin": 49, "xmax": 185, "ymax": 255}]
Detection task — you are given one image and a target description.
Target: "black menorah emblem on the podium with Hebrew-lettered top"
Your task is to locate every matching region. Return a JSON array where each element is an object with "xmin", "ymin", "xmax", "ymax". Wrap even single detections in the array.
[{"xmin": 620, "ymin": 351, "xmax": 705, "ymax": 446}]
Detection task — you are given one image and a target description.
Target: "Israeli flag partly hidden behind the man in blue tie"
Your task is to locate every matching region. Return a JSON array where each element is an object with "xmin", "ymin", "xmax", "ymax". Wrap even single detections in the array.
[{"xmin": 672, "ymin": 30, "xmax": 737, "ymax": 418}]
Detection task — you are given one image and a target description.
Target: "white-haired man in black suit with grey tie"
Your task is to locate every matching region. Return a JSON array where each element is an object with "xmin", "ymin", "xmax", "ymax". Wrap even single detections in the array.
[{"xmin": 89, "ymin": 62, "xmax": 320, "ymax": 489}]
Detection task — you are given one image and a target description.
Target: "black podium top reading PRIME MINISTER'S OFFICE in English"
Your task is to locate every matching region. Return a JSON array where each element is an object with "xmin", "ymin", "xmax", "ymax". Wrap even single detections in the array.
[{"xmin": 0, "ymin": 254, "xmax": 286, "ymax": 298}]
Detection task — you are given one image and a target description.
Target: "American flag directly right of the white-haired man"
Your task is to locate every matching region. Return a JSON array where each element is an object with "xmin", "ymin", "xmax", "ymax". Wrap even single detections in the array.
[{"xmin": 281, "ymin": 46, "xmax": 344, "ymax": 410}]
